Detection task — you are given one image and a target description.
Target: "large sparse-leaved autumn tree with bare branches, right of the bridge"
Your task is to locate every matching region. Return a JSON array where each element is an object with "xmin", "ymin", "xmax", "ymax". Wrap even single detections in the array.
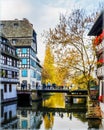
[{"xmin": 45, "ymin": 9, "xmax": 101, "ymax": 94}]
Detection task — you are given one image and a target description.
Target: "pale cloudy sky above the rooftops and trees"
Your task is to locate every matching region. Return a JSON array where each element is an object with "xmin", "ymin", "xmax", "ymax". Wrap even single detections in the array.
[{"xmin": 0, "ymin": 0, "xmax": 103, "ymax": 63}]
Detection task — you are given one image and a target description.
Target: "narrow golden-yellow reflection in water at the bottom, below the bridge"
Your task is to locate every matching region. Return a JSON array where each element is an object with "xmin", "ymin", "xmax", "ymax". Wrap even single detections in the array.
[{"xmin": 43, "ymin": 112, "xmax": 54, "ymax": 129}]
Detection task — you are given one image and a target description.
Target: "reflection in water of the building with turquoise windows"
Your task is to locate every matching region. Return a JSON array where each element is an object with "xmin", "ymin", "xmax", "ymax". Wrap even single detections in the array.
[{"xmin": 17, "ymin": 109, "xmax": 42, "ymax": 129}]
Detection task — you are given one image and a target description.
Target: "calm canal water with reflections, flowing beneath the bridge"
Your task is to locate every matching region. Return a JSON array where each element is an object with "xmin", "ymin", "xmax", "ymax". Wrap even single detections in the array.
[{"xmin": 0, "ymin": 93, "xmax": 104, "ymax": 130}]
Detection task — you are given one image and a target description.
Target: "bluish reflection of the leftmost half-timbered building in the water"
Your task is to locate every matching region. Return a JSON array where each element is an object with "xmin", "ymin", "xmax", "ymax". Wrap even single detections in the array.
[{"xmin": 0, "ymin": 103, "xmax": 18, "ymax": 130}]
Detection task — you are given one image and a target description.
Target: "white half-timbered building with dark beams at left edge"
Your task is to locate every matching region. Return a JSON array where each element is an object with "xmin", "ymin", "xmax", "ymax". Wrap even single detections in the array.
[{"xmin": 0, "ymin": 33, "xmax": 19, "ymax": 103}]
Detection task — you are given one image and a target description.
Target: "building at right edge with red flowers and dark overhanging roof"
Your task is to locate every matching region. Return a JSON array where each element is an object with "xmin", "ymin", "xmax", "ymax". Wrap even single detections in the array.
[{"xmin": 88, "ymin": 11, "xmax": 104, "ymax": 118}]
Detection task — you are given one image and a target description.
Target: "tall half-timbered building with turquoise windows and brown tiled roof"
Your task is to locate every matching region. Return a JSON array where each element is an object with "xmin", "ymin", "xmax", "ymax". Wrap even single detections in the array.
[{"xmin": 1, "ymin": 18, "xmax": 42, "ymax": 89}]
